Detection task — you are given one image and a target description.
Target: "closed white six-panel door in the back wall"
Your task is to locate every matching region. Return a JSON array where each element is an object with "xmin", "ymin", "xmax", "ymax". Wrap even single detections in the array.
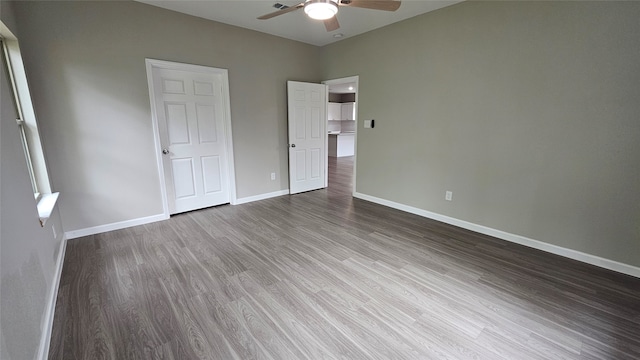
[{"xmin": 152, "ymin": 67, "xmax": 230, "ymax": 214}]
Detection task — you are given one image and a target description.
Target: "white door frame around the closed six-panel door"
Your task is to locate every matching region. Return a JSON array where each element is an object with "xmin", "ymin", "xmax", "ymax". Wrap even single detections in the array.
[{"xmin": 145, "ymin": 58, "xmax": 237, "ymax": 219}]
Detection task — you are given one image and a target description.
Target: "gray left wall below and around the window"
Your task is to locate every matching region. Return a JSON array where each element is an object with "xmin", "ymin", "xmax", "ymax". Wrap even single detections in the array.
[{"xmin": 0, "ymin": 1, "xmax": 62, "ymax": 360}]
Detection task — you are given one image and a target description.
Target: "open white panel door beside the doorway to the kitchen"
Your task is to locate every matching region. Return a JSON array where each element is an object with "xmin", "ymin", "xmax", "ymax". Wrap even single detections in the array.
[{"xmin": 287, "ymin": 81, "xmax": 327, "ymax": 194}]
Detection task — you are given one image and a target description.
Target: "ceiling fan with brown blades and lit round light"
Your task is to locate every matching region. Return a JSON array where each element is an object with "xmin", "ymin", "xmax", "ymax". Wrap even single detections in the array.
[{"xmin": 258, "ymin": 0, "xmax": 401, "ymax": 31}]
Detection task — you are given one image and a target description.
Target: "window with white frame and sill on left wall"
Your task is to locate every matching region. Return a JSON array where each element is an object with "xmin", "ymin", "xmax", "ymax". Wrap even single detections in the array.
[{"xmin": 0, "ymin": 22, "xmax": 58, "ymax": 225}]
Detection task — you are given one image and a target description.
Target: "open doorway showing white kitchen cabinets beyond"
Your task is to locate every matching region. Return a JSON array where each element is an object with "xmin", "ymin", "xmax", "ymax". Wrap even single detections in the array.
[{"xmin": 323, "ymin": 76, "xmax": 358, "ymax": 194}]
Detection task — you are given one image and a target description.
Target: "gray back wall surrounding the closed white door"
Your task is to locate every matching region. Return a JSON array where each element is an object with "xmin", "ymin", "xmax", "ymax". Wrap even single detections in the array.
[{"xmin": 14, "ymin": 1, "xmax": 321, "ymax": 231}]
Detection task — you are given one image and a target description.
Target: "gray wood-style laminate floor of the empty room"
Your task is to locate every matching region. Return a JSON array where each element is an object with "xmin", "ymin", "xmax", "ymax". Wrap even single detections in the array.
[{"xmin": 49, "ymin": 158, "xmax": 640, "ymax": 360}]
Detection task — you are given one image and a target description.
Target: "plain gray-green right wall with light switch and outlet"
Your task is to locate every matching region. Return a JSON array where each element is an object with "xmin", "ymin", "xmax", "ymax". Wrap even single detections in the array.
[{"xmin": 323, "ymin": 1, "xmax": 640, "ymax": 266}]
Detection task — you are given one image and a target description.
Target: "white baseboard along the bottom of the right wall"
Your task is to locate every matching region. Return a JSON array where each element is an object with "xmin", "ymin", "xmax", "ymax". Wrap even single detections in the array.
[{"xmin": 353, "ymin": 192, "xmax": 640, "ymax": 278}]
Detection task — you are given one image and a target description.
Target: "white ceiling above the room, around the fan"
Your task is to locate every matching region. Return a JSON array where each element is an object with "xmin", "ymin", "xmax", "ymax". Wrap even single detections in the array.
[{"xmin": 136, "ymin": 0, "xmax": 463, "ymax": 46}]
